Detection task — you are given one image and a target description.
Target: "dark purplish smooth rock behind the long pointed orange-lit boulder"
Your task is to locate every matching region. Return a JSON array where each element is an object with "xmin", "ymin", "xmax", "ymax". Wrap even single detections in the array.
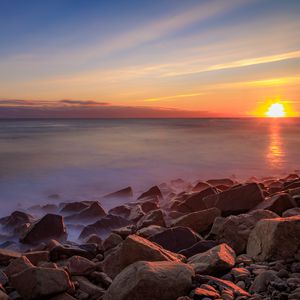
[{"xmin": 149, "ymin": 227, "xmax": 201, "ymax": 252}]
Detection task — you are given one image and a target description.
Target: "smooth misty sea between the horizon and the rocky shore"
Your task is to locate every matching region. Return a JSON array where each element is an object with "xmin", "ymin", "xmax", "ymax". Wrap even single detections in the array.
[{"xmin": 0, "ymin": 119, "xmax": 300, "ymax": 214}]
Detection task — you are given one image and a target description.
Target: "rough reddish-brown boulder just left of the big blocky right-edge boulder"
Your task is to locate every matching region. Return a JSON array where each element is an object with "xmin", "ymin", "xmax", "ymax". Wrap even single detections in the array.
[{"xmin": 209, "ymin": 210, "xmax": 278, "ymax": 254}]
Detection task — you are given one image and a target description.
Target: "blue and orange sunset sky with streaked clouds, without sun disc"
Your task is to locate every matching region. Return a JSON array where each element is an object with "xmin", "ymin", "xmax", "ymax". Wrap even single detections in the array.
[{"xmin": 0, "ymin": 0, "xmax": 300, "ymax": 118}]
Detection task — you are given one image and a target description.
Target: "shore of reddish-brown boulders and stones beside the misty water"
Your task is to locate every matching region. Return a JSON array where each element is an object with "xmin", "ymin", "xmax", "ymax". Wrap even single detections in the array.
[{"xmin": 0, "ymin": 173, "xmax": 300, "ymax": 300}]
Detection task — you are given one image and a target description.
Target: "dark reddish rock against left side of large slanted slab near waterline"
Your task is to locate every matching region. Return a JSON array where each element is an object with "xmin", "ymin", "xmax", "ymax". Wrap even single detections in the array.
[{"xmin": 176, "ymin": 187, "xmax": 217, "ymax": 213}]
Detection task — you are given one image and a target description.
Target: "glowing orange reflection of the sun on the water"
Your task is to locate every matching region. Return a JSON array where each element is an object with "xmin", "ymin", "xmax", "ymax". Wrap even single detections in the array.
[{"xmin": 267, "ymin": 120, "xmax": 285, "ymax": 168}]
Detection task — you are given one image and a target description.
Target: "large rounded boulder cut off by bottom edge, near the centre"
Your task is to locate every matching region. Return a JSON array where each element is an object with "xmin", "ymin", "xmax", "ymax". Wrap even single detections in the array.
[{"xmin": 103, "ymin": 261, "xmax": 194, "ymax": 300}]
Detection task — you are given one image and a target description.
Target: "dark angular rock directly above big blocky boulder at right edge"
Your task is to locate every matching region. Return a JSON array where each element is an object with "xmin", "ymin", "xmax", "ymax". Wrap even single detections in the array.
[{"xmin": 256, "ymin": 193, "xmax": 297, "ymax": 216}]
